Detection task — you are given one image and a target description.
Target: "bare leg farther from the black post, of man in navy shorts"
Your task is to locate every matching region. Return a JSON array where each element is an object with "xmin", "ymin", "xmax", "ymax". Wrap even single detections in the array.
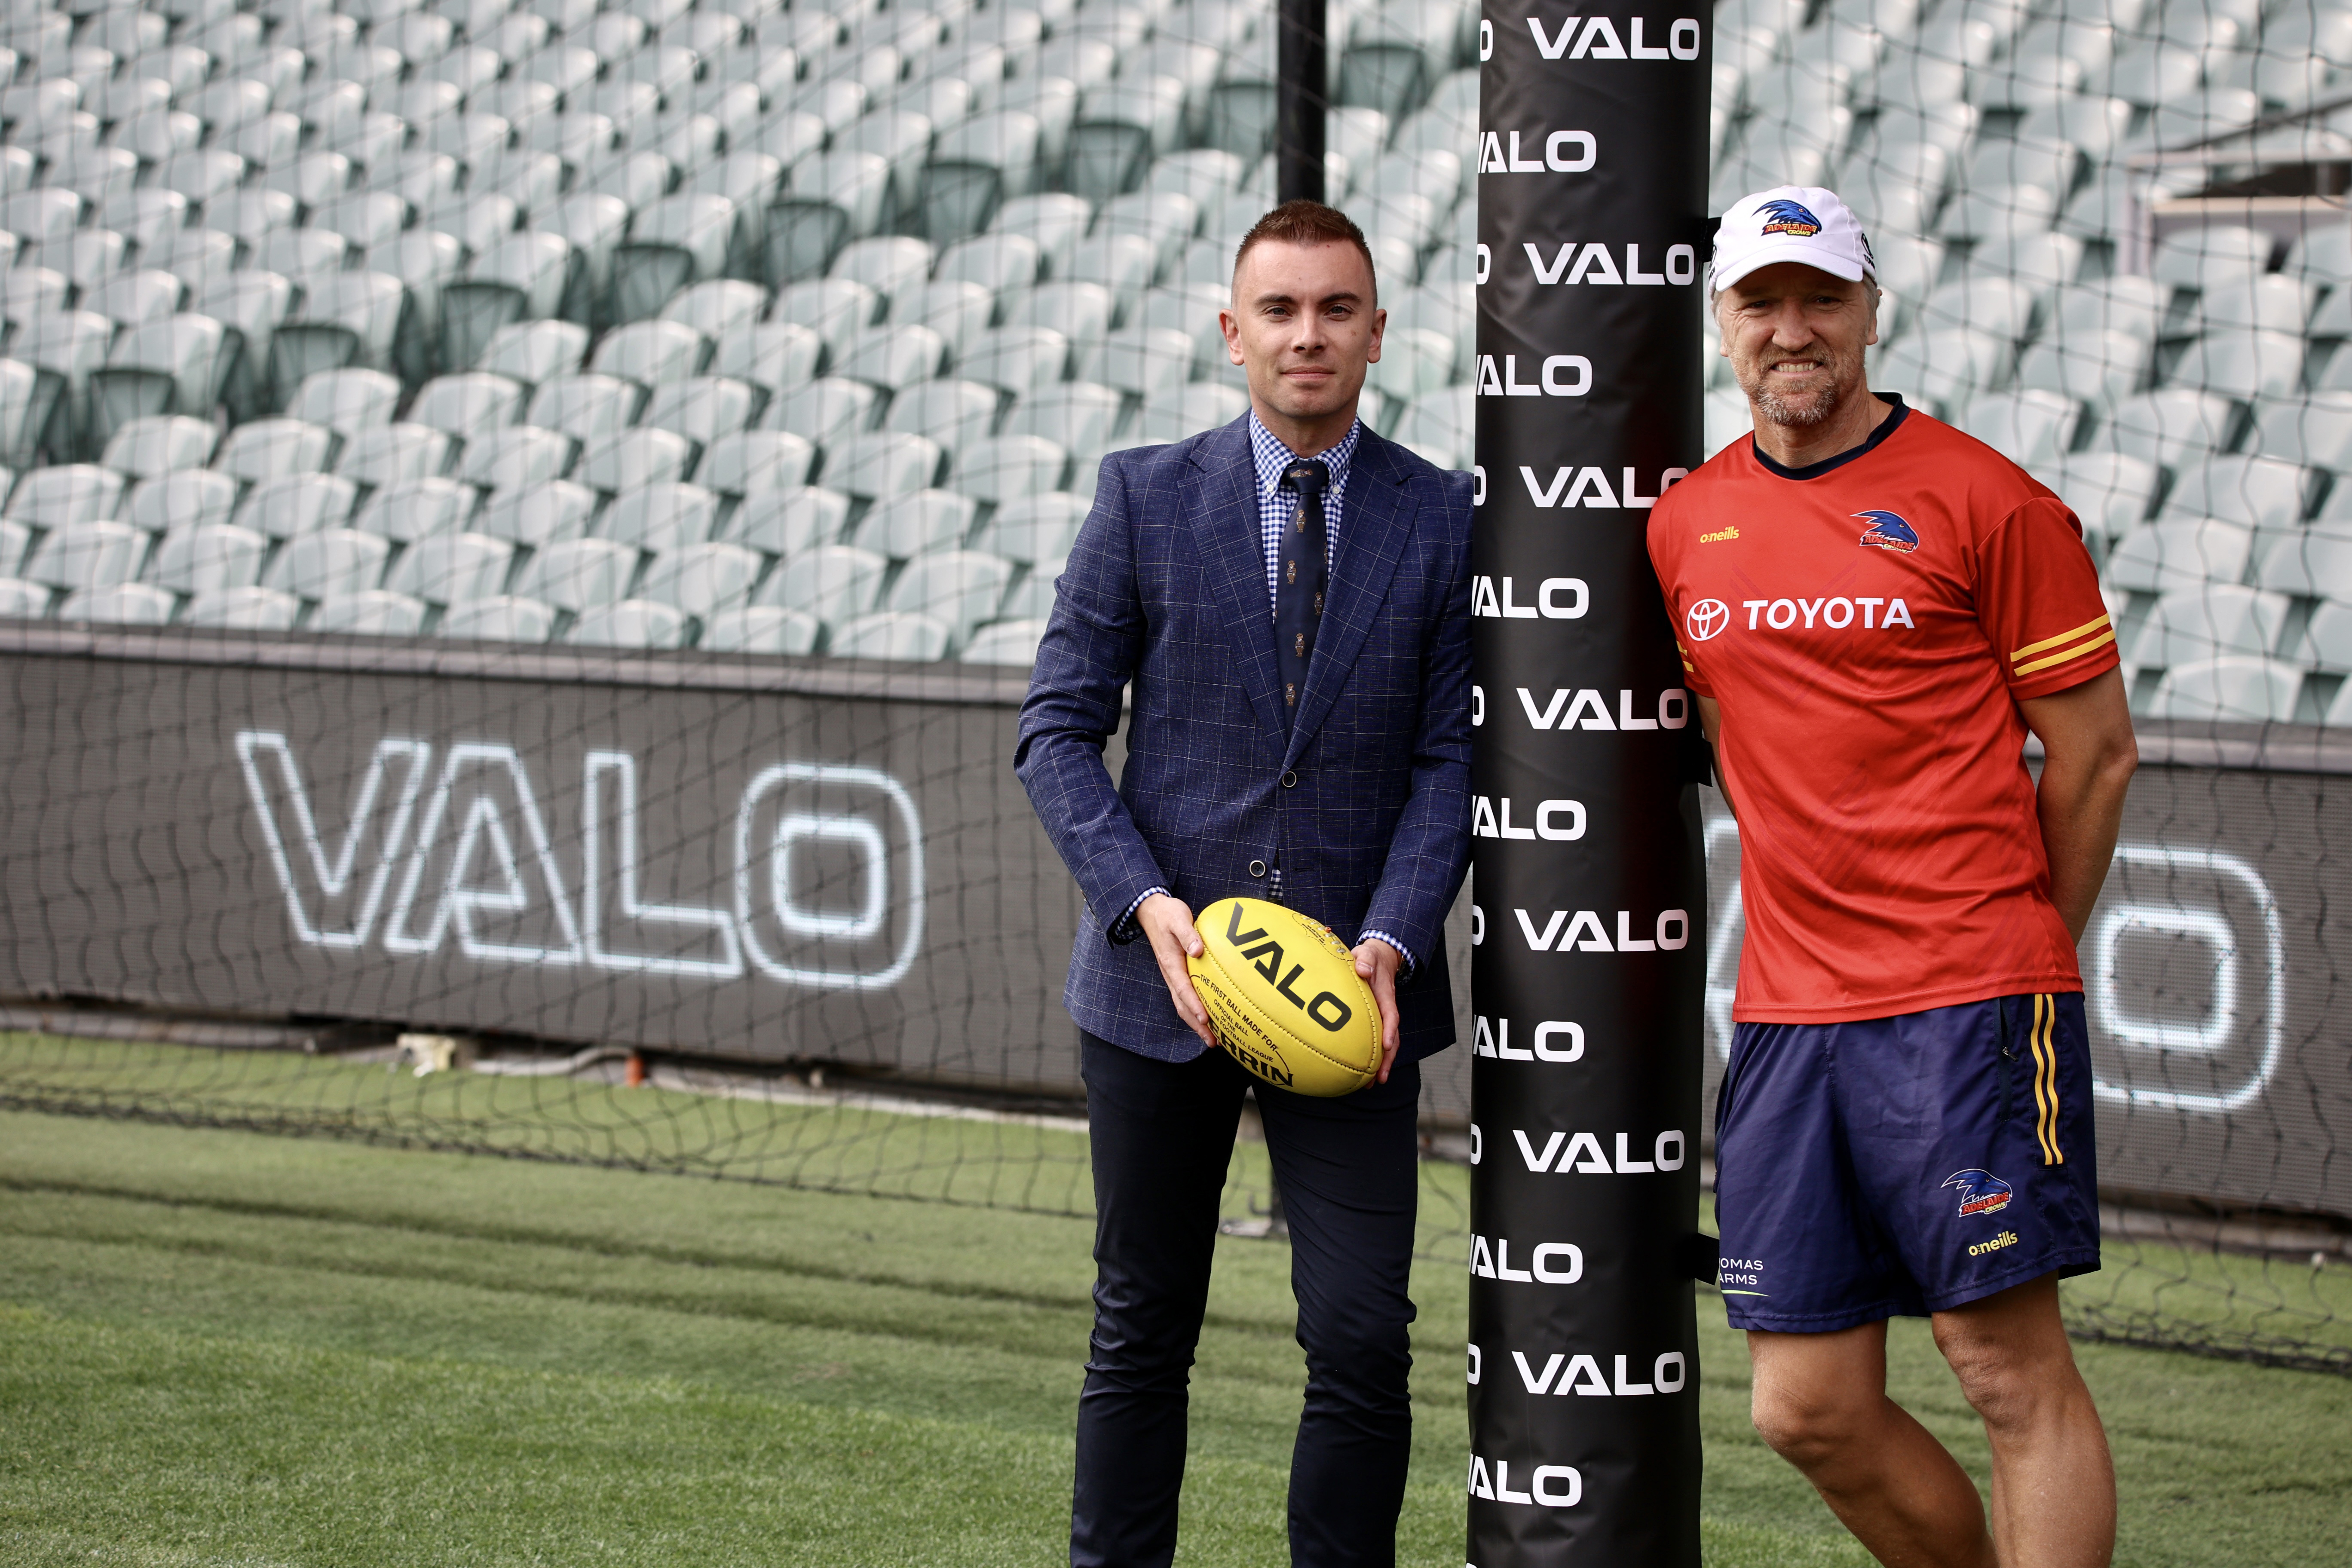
[{"xmin": 1936, "ymin": 1274, "xmax": 2114, "ymax": 1568}]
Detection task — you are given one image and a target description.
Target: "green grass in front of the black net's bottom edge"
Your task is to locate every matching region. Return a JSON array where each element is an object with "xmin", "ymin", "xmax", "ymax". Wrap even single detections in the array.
[{"xmin": 0, "ymin": 1086, "xmax": 2352, "ymax": 1568}]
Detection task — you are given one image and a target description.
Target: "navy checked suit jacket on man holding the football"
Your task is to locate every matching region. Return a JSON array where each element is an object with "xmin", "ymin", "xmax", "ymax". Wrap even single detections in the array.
[{"xmin": 1014, "ymin": 414, "xmax": 1470, "ymax": 1063}]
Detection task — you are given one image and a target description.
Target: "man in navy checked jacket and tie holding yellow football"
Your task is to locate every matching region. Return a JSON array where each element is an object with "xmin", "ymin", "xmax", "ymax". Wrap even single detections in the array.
[{"xmin": 1016, "ymin": 202, "xmax": 1470, "ymax": 1568}]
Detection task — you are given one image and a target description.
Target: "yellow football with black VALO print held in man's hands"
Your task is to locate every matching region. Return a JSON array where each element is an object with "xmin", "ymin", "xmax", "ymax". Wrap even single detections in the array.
[{"xmin": 1185, "ymin": 898, "xmax": 1381, "ymax": 1098}]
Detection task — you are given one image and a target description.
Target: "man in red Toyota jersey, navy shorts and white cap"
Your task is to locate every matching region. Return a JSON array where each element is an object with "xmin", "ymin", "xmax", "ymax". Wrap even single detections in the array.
[{"xmin": 1649, "ymin": 186, "xmax": 2138, "ymax": 1568}]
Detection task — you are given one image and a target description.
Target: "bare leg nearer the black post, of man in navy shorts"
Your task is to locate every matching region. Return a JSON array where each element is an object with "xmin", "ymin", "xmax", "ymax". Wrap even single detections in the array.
[{"xmin": 1748, "ymin": 1323, "xmax": 2002, "ymax": 1568}]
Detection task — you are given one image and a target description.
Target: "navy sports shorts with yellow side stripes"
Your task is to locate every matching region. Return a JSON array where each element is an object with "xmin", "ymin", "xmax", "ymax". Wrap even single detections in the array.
[{"xmin": 1715, "ymin": 992, "xmax": 2098, "ymax": 1333}]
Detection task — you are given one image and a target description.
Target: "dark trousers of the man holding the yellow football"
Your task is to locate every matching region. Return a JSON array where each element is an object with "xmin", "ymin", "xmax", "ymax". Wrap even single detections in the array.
[{"xmin": 1070, "ymin": 1032, "xmax": 1421, "ymax": 1568}]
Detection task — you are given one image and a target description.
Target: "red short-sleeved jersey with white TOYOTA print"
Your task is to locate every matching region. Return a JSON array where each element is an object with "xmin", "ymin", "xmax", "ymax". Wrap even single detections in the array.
[{"xmin": 1649, "ymin": 397, "xmax": 2117, "ymax": 1023}]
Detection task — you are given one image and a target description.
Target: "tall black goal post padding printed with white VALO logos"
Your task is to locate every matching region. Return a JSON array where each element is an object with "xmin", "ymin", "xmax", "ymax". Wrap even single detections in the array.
[{"xmin": 1465, "ymin": 0, "xmax": 1712, "ymax": 1568}]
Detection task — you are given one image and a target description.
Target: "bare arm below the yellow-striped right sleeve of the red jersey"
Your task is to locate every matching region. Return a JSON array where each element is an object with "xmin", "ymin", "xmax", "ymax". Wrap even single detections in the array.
[{"xmin": 2018, "ymin": 670, "xmax": 2141, "ymax": 943}]
